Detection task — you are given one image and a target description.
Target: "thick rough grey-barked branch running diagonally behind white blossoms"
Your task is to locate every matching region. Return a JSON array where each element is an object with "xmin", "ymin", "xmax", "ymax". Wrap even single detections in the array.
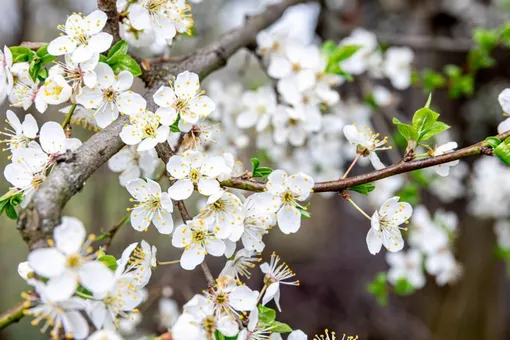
[{"xmin": 18, "ymin": 0, "xmax": 307, "ymax": 249}]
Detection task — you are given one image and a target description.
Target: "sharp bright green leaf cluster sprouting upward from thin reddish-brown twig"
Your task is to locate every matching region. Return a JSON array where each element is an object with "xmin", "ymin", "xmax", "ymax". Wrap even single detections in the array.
[{"xmin": 393, "ymin": 96, "xmax": 450, "ymax": 143}]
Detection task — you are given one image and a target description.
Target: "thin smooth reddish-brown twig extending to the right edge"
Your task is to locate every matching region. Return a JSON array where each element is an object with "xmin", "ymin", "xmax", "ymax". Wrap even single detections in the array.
[{"xmin": 221, "ymin": 131, "xmax": 510, "ymax": 192}]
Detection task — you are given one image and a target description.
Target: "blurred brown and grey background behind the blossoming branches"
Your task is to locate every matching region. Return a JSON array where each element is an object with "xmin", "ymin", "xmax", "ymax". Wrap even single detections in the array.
[{"xmin": 0, "ymin": 0, "xmax": 510, "ymax": 340}]
